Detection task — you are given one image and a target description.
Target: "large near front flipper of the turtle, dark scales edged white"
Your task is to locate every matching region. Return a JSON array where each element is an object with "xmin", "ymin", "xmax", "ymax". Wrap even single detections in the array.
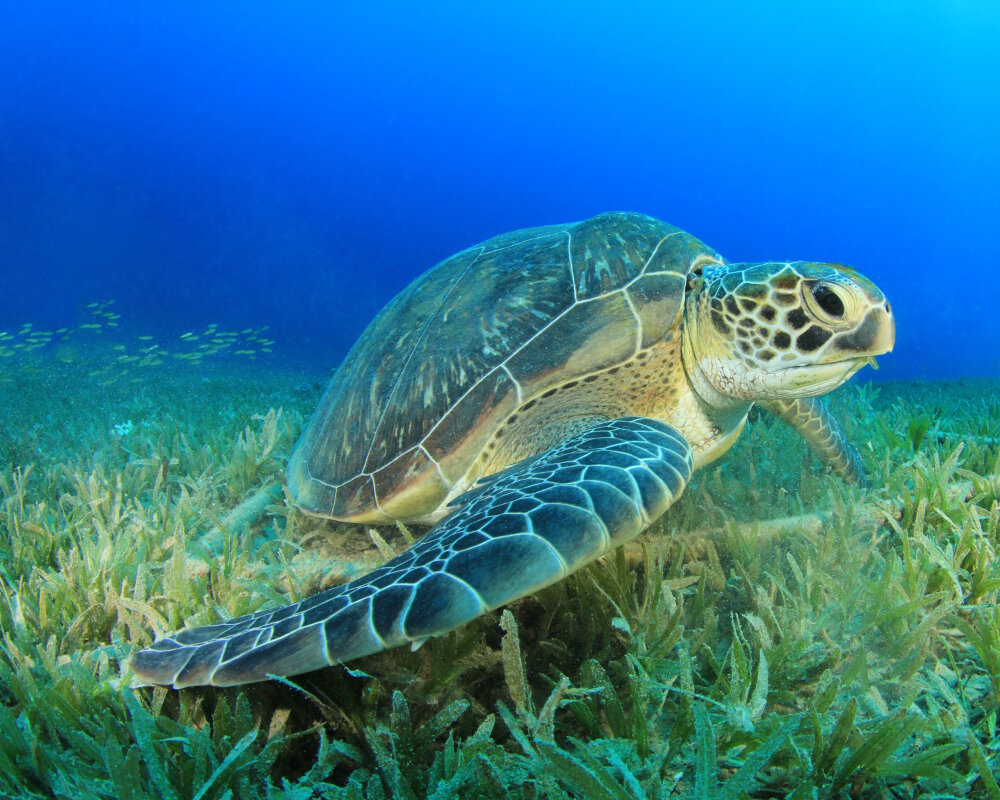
[{"xmin": 132, "ymin": 417, "xmax": 692, "ymax": 688}]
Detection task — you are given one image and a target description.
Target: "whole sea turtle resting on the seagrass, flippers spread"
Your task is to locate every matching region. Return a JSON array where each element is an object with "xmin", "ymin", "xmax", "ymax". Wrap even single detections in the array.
[{"xmin": 132, "ymin": 213, "xmax": 895, "ymax": 688}]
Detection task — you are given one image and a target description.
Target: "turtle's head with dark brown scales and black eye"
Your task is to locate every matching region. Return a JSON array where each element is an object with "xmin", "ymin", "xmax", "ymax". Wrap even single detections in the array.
[{"xmin": 684, "ymin": 261, "xmax": 896, "ymax": 407}]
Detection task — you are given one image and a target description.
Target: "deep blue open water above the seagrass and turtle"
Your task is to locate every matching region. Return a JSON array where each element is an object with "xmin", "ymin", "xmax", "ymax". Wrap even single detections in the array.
[{"xmin": 0, "ymin": 0, "xmax": 1000, "ymax": 378}]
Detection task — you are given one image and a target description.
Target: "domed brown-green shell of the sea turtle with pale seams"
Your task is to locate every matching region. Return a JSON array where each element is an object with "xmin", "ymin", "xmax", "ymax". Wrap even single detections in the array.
[{"xmin": 288, "ymin": 213, "xmax": 719, "ymax": 522}]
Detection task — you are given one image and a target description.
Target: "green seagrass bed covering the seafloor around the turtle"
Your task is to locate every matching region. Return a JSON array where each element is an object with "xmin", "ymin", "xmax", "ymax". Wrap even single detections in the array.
[{"xmin": 0, "ymin": 324, "xmax": 1000, "ymax": 800}]
